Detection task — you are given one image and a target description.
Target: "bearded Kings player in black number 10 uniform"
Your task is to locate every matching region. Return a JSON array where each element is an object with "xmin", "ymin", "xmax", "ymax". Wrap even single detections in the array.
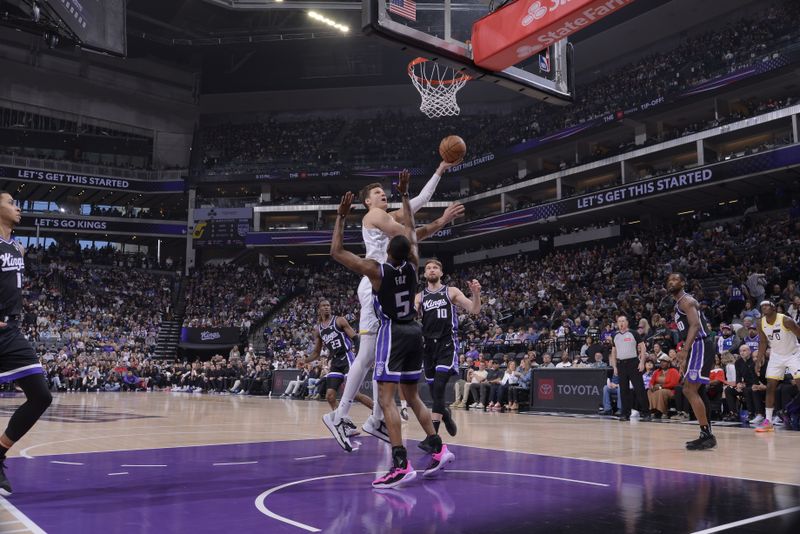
[{"xmin": 415, "ymin": 259, "xmax": 481, "ymax": 436}]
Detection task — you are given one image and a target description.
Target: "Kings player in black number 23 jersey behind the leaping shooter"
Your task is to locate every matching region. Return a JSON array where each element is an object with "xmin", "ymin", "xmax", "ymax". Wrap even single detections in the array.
[{"xmin": 306, "ymin": 299, "xmax": 372, "ymax": 446}]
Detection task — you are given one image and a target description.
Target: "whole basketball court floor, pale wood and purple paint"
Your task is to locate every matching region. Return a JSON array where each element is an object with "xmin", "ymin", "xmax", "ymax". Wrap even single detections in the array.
[{"xmin": 0, "ymin": 393, "xmax": 800, "ymax": 534}]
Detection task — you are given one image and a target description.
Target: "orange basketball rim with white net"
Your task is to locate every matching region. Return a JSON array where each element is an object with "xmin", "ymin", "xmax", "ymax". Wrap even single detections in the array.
[{"xmin": 408, "ymin": 57, "xmax": 472, "ymax": 119}]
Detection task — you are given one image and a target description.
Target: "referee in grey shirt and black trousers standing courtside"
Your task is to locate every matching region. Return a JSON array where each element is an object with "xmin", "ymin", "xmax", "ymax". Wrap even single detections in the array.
[{"xmin": 610, "ymin": 315, "xmax": 650, "ymax": 421}]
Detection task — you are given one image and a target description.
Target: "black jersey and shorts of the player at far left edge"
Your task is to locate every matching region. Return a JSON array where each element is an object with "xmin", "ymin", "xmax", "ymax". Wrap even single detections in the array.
[{"xmin": 0, "ymin": 238, "xmax": 44, "ymax": 382}]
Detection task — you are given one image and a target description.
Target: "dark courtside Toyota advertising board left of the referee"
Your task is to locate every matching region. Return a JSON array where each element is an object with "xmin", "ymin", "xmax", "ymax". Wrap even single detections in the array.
[{"xmin": 531, "ymin": 368, "xmax": 608, "ymax": 413}]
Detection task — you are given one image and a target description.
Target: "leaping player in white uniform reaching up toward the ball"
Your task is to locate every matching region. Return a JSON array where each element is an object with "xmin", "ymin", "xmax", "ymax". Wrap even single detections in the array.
[{"xmin": 322, "ymin": 161, "xmax": 464, "ymax": 452}]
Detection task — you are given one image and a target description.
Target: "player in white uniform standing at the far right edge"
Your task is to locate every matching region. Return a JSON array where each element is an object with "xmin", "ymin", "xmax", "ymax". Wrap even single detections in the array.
[{"xmin": 756, "ymin": 300, "xmax": 800, "ymax": 432}]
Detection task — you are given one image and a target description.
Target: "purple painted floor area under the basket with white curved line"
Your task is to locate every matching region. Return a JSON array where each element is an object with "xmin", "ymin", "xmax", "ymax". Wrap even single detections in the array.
[{"xmin": 6, "ymin": 438, "xmax": 800, "ymax": 534}]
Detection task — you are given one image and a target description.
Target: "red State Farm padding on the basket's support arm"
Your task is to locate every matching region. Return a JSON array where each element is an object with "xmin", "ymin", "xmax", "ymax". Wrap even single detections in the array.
[{"xmin": 472, "ymin": 0, "xmax": 633, "ymax": 71}]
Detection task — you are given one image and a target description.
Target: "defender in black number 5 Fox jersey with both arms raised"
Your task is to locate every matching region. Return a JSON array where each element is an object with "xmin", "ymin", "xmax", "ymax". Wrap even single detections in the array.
[{"xmin": 331, "ymin": 171, "xmax": 449, "ymax": 488}]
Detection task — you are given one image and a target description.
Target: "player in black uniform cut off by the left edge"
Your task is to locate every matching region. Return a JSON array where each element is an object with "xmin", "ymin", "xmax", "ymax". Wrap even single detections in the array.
[{"xmin": 0, "ymin": 193, "xmax": 53, "ymax": 496}]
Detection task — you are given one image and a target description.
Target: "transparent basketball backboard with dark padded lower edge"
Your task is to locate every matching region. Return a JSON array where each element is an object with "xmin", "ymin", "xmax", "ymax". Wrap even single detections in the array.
[{"xmin": 362, "ymin": 0, "xmax": 574, "ymax": 105}]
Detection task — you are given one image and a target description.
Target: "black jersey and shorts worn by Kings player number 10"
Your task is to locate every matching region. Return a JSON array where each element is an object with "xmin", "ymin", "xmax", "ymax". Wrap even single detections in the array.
[{"xmin": 420, "ymin": 285, "xmax": 458, "ymax": 382}]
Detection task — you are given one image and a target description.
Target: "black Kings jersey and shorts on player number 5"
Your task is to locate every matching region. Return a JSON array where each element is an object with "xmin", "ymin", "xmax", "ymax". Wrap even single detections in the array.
[{"xmin": 373, "ymin": 262, "xmax": 422, "ymax": 382}]
